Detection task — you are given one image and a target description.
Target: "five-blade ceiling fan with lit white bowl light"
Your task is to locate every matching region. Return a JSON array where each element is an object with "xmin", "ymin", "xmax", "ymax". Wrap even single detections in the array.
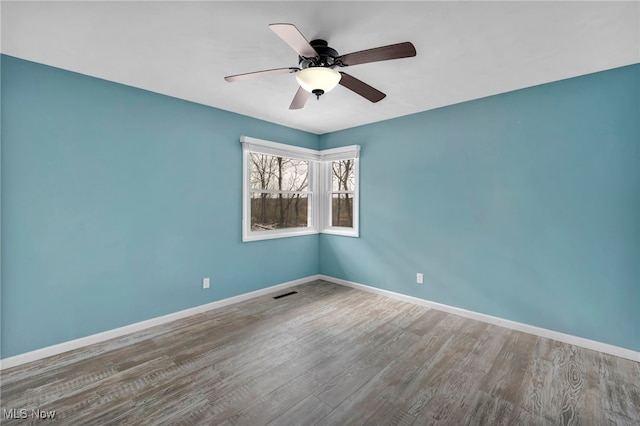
[{"xmin": 224, "ymin": 24, "xmax": 416, "ymax": 109}]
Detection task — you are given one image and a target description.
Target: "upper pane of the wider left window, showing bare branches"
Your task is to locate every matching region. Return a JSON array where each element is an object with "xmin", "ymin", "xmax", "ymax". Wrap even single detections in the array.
[{"xmin": 250, "ymin": 153, "xmax": 309, "ymax": 191}]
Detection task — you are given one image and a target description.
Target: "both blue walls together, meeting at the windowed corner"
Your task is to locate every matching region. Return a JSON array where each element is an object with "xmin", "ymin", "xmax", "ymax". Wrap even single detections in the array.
[{"xmin": 0, "ymin": 56, "xmax": 640, "ymax": 358}]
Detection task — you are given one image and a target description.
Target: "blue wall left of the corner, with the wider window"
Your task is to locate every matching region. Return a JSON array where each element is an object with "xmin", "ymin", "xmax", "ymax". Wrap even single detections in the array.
[{"xmin": 1, "ymin": 56, "xmax": 319, "ymax": 358}]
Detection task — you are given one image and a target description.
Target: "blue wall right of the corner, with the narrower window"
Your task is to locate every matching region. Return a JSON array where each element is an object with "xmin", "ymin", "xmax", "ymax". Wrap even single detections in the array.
[{"xmin": 320, "ymin": 65, "xmax": 640, "ymax": 351}]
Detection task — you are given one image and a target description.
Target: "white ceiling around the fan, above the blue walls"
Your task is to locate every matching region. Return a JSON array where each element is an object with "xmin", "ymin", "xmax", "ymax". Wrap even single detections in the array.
[{"xmin": 0, "ymin": 1, "xmax": 640, "ymax": 134}]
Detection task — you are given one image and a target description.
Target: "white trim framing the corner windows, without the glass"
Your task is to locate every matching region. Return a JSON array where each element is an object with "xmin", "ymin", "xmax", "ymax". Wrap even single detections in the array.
[{"xmin": 240, "ymin": 136, "xmax": 360, "ymax": 242}]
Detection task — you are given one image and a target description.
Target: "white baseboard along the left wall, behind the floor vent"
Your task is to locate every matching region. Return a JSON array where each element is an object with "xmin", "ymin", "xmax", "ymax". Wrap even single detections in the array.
[{"xmin": 0, "ymin": 275, "xmax": 320, "ymax": 370}]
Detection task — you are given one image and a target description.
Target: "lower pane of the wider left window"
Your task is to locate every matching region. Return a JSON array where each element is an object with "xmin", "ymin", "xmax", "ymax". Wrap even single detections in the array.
[{"xmin": 251, "ymin": 192, "xmax": 309, "ymax": 231}]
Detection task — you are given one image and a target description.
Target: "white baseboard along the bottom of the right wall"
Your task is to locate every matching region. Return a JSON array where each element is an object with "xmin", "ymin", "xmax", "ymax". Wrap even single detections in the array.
[{"xmin": 320, "ymin": 275, "xmax": 640, "ymax": 362}]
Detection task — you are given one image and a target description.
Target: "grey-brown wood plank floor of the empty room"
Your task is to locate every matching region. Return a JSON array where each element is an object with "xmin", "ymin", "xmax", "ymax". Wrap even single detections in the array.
[{"xmin": 0, "ymin": 281, "xmax": 640, "ymax": 426}]
